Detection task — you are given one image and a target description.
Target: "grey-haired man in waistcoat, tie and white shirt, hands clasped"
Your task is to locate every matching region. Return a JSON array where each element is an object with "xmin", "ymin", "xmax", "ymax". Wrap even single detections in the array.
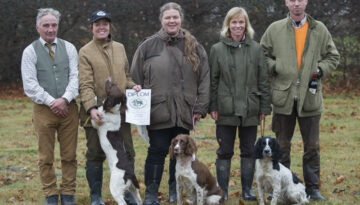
[{"xmin": 21, "ymin": 8, "xmax": 79, "ymax": 205}]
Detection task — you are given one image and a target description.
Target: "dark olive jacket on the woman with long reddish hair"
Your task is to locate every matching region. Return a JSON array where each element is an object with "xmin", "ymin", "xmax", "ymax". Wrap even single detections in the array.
[{"xmin": 131, "ymin": 30, "xmax": 210, "ymax": 130}]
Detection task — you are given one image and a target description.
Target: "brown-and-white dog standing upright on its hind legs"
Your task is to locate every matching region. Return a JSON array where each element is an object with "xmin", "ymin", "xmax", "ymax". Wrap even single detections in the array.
[{"xmin": 91, "ymin": 79, "xmax": 142, "ymax": 205}]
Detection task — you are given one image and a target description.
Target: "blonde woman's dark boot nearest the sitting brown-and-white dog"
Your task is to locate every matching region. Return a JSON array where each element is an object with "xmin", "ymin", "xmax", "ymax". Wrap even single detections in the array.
[{"xmin": 215, "ymin": 159, "xmax": 231, "ymax": 200}]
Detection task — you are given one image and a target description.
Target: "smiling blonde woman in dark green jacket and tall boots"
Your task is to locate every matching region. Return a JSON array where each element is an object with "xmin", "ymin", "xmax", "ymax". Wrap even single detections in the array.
[{"xmin": 209, "ymin": 7, "xmax": 271, "ymax": 200}]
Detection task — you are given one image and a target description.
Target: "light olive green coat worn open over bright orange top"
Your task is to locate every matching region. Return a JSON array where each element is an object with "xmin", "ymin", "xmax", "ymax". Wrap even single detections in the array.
[{"xmin": 260, "ymin": 15, "xmax": 340, "ymax": 117}]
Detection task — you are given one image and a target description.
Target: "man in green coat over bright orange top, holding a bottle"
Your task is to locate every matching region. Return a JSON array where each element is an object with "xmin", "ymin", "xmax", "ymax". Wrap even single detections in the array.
[{"xmin": 260, "ymin": 0, "xmax": 339, "ymax": 200}]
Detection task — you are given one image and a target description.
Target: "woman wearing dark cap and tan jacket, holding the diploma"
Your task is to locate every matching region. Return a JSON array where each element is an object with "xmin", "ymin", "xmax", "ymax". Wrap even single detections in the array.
[{"xmin": 79, "ymin": 11, "xmax": 141, "ymax": 205}]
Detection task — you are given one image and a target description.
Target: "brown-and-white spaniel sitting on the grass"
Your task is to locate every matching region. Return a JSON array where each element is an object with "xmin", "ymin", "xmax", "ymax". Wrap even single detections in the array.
[{"xmin": 169, "ymin": 134, "xmax": 224, "ymax": 205}]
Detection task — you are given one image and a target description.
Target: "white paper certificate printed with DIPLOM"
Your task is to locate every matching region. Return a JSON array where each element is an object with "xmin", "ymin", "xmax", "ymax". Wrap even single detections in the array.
[{"xmin": 125, "ymin": 89, "xmax": 151, "ymax": 125}]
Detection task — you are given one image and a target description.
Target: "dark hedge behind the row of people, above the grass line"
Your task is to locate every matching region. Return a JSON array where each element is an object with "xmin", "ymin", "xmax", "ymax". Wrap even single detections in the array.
[{"xmin": 0, "ymin": 0, "xmax": 360, "ymax": 84}]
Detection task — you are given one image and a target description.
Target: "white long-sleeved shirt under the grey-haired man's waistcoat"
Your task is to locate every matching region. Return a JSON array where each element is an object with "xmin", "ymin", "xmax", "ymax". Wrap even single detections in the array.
[{"xmin": 21, "ymin": 38, "xmax": 79, "ymax": 106}]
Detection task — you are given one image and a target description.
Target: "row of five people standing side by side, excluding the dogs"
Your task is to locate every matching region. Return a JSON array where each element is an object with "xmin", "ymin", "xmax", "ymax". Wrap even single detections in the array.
[{"xmin": 21, "ymin": 0, "xmax": 339, "ymax": 205}]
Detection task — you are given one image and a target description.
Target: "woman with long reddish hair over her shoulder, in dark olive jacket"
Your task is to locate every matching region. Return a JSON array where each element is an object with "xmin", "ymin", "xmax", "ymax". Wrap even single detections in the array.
[{"xmin": 131, "ymin": 2, "xmax": 210, "ymax": 205}]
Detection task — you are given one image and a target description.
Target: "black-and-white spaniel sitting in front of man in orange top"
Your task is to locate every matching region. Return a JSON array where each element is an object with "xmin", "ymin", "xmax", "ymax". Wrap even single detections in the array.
[{"xmin": 255, "ymin": 137, "xmax": 309, "ymax": 205}]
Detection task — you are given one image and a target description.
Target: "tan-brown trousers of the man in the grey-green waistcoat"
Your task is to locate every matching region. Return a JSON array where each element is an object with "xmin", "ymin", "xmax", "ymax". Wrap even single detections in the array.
[{"xmin": 33, "ymin": 102, "xmax": 79, "ymax": 197}]
